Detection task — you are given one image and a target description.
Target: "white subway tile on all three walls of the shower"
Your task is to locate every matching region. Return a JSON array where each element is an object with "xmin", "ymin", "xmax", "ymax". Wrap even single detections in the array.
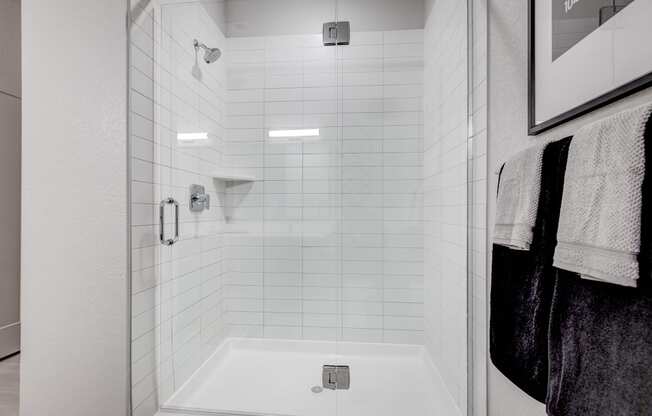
[{"xmin": 130, "ymin": 4, "xmax": 478, "ymax": 416}]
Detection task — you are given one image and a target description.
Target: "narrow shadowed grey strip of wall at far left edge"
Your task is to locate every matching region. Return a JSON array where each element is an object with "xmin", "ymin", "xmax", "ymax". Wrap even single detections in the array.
[{"xmin": 0, "ymin": 0, "xmax": 21, "ymax": 358}]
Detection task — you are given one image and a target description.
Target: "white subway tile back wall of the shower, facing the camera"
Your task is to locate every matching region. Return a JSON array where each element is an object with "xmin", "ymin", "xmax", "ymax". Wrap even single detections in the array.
[{"xmin": 224, "ymin": 30, "xmax": 424, "ymax": 344}]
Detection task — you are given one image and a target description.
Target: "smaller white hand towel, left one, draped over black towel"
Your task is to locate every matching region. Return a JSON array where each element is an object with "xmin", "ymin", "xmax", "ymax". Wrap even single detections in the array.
[{"xmin": 494, "ymin": 145, "xmax": 544, "ymax": 250}]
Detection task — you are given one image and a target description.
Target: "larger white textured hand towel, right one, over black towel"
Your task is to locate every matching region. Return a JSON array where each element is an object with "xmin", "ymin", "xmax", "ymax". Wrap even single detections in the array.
[{"xmin": 554, "ymin": 104, "xmax": 652, "ymax": 287}]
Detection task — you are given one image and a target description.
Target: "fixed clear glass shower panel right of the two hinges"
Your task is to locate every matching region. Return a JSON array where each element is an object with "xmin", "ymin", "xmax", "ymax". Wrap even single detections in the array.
[{"xmin": 337, "ymin": 0, "xmax": 468, "ymax": 416}]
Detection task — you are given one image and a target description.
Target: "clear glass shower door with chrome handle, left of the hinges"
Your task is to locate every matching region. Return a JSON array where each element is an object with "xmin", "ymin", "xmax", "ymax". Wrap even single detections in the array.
[{"xmin": 130, "ymin": 0, "xmax": 342, "ymax": 415}]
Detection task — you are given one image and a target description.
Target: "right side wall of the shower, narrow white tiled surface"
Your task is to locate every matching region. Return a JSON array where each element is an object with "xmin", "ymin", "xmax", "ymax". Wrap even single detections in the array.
[{"xmin": 424, "ymin": 0, "xmax": 468, "ymax": 414}]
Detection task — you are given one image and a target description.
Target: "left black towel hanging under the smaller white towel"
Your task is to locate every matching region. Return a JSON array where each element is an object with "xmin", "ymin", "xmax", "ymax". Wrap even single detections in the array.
[{"xmin": 490, "ymin": 138, "xmax": 571, "ymax": 403}]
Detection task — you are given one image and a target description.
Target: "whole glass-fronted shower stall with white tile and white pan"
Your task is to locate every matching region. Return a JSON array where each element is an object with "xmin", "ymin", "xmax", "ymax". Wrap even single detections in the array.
[{"xmin": 129, "ymin": 0, "xmax": 473, "ymax": 416}]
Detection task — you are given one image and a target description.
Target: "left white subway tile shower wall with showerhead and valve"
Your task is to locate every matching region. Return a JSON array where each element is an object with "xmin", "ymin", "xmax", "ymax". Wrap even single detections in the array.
[{"xmin": 130, "ymin": 1, "xmax": 226, "ymax": 416}]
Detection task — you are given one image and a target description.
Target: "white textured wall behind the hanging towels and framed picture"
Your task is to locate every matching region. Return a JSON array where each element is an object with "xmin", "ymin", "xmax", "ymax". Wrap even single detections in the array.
[{"xmin": 487, "ymin": 0, "xmax": 652, "ymax": 416}]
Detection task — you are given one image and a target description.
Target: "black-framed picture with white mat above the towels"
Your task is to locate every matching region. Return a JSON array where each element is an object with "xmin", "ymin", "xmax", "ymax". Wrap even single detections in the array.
[{"xmin": 528, "ymin": 0, "xmax": 652, "ymax": 135}]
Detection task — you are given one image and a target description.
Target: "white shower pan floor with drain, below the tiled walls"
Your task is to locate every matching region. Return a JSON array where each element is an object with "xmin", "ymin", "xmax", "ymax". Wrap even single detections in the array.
[{"xmin": 159, "ymin": 338, "xmax": 460, "ymax": 416}]
